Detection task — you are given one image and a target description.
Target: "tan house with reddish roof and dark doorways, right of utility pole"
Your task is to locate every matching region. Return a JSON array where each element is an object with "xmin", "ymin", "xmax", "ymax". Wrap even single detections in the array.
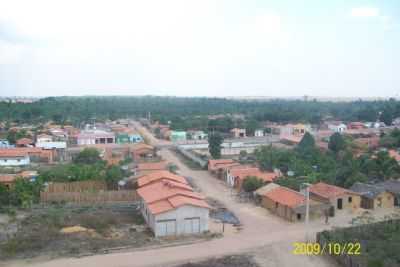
[{"xmin": 309, "ymin": 182, "xmax": 361, "ymax": 214}]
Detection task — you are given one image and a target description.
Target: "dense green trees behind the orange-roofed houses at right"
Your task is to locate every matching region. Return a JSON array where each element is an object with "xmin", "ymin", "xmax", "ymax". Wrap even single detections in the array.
[{"xmin": 255, "ymin": 133, "xmax": 400, "ymax": 190}]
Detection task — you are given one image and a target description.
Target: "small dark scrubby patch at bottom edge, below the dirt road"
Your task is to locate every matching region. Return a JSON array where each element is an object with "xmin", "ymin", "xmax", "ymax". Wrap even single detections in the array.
[{"xmin": 177, "ymin": 255, "xmax": 259, "ymax": 267}]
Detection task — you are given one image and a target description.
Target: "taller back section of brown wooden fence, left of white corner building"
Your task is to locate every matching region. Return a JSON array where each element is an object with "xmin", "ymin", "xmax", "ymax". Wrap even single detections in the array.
[{"xmin": 45, "ymin": 181, "xmax": 107, "ymax": 193}]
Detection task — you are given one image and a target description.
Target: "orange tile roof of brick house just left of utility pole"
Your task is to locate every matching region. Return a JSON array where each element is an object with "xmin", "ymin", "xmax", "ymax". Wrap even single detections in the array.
[{"xmin": 264, "ymin": 186, "xmax": 305, "ymax": 208}]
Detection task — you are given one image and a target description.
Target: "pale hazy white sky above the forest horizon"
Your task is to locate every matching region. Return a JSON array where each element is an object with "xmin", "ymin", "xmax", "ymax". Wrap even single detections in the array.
[{"xmin": 0, "ymin": 0, "xmax": 400, "ymax": 97}]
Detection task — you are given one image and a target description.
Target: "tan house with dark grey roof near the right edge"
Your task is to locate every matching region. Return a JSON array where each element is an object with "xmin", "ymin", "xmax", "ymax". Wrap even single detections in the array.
[{"xmin": 350, "ymin": 182, "xmax": 395, "ymax": 209}]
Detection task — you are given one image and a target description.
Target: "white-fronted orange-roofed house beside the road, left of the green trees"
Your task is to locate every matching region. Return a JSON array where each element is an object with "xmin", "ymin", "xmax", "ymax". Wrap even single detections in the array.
[{"xmin": 226, "ymin": 165, "xmax": 278, "ymax": 192}]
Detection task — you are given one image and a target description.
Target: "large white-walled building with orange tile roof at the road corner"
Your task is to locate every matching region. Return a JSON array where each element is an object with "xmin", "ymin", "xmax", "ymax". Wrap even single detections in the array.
[{"xmin": 137, "ymin": 176, "xmax": 210, "ymax": 237}]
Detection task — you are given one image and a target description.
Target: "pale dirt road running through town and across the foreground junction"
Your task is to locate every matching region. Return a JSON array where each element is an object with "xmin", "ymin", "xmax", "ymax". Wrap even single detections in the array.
[{"xmin": 4, "ymin": 149, "xmax": 340, "ymax": 267}]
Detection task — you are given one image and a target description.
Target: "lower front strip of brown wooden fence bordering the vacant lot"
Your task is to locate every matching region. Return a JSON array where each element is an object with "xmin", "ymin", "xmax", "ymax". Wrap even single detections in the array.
[{"xmin": 40, "ymin": 190, "xmax": 139, "ymax": 203}]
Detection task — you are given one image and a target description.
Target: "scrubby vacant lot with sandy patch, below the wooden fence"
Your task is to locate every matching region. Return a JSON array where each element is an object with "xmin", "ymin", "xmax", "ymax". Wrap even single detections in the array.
[{"xmin": 0, "ymin": 206, "xmax": 155, "ymax": 259}]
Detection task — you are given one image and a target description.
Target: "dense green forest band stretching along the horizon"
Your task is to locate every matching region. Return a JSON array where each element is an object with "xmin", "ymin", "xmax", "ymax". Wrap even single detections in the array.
[{"xmin": 0, "ymin": 96, "xmax": 400, "ymax": 129}]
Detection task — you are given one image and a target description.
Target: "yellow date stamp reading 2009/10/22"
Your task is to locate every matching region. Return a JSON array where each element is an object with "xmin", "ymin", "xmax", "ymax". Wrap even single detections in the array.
[{"xmin": 292, "ymin": 242, "xmax": 361, "ymax": 256}]
